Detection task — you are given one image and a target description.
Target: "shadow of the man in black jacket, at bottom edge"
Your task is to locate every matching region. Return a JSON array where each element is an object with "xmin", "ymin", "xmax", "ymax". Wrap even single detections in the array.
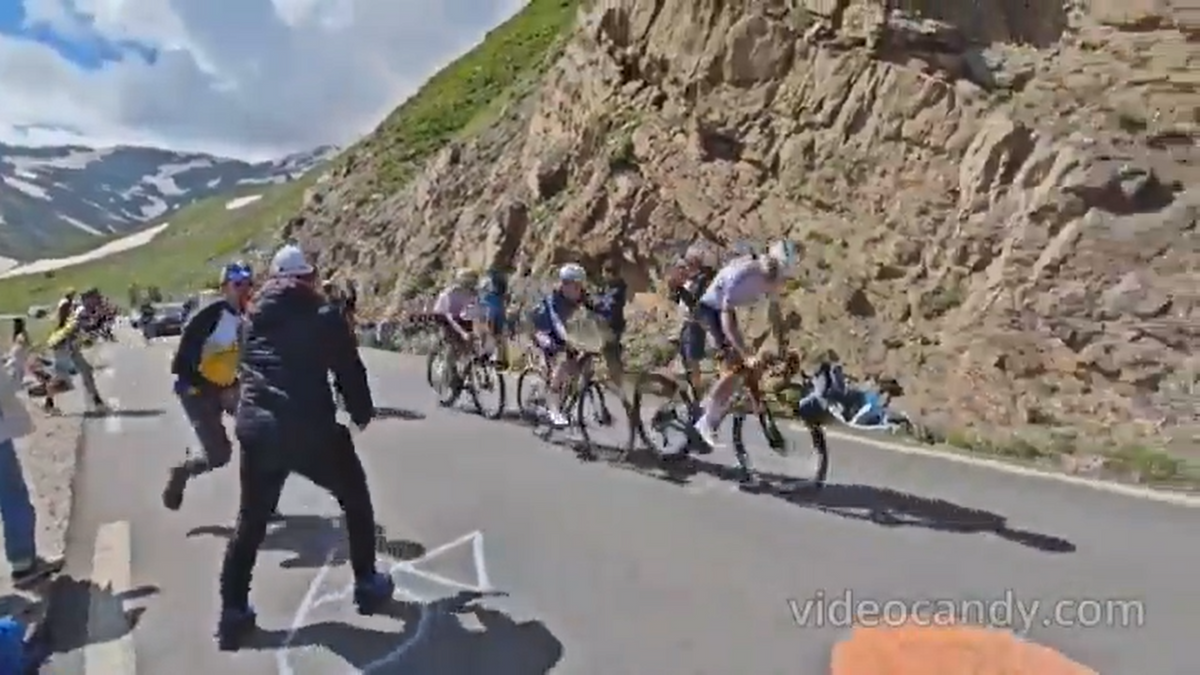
[{"xmin": 246, "ymin": 592, "xmax": 563, "ymax": 675}]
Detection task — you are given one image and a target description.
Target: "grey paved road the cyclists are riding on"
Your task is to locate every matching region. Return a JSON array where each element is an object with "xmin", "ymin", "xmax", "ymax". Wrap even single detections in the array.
[{"xmin": 39, "ymin": 336, "xmax": 1200, "ymax": 675}]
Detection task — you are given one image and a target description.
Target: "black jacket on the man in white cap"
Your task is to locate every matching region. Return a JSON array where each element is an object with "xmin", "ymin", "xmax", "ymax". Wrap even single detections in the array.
[{"xmin": 236, "ymin": 279, "xmax": 374, "ymax": 444}]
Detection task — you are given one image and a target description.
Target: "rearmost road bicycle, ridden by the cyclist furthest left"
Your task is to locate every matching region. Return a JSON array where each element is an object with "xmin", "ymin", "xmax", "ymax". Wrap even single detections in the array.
[{"xmin": 425, "ymin": 340, "xmax": 508, "ymax": 419}]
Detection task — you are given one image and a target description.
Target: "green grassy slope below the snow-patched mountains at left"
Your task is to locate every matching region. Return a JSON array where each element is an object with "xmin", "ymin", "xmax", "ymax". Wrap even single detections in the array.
[{"xmin": 0, "ymin": 176, "xmax": 319, "ymax": 313}]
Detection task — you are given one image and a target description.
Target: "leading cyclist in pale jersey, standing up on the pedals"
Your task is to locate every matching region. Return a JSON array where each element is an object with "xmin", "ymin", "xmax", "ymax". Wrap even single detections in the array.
[{"xmin": 682, "ymin": 241, "xmax": 799, "ymax": 454}]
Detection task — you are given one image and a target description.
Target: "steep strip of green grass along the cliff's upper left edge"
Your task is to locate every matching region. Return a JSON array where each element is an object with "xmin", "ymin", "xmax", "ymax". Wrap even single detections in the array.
[{"xmin": 347, "ymin": 0, "xmax": 578, "ymax": 192}]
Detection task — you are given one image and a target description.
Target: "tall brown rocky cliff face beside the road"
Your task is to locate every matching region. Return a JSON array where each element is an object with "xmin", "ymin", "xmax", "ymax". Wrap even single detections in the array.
[{"xmin": 288, "ymin": 0, "xmax": 1200, "ymax": 447}]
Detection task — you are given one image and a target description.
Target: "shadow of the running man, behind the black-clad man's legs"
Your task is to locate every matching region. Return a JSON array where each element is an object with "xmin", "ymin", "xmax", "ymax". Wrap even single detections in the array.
[{"xmin": 187, "ymin": 514, "xmax": 425, "ymax": 569}]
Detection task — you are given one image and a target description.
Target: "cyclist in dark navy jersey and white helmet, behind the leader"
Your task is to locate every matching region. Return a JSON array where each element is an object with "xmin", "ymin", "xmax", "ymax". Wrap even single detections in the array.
[{"xmin": 529, "ymin": 263, "xmax": 602, "ymax": 426}]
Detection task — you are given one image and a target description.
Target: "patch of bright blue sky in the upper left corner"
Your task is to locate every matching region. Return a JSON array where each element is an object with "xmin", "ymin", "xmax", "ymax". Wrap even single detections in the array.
[{"xmin": 0, "ymin": 0, "xmax": 157, "ymax": 70}]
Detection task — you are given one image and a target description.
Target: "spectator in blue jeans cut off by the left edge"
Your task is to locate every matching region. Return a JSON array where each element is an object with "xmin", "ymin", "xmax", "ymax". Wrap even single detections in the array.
[{"xmin": 0, "ymin": 343, "xmax": 62, "ymax": 587}]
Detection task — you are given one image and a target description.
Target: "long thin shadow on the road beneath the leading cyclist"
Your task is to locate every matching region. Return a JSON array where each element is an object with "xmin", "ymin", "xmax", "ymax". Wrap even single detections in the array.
[{"xmin": 585, "ymin": 452, "xmax": 1075, "ymax": 554}]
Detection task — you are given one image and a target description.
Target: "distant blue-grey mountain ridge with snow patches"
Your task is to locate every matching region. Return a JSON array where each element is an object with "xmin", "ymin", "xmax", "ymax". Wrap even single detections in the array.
[{"xmin": 0, "ymin": 143, "xmax": 337, "ymax": 261}]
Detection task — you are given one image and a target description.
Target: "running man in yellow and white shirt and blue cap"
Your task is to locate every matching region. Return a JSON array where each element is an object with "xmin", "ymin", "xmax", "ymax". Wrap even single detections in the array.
[{"xmin": 162, "ymin": 263, "xmax": 265, "ymax": 510}]
